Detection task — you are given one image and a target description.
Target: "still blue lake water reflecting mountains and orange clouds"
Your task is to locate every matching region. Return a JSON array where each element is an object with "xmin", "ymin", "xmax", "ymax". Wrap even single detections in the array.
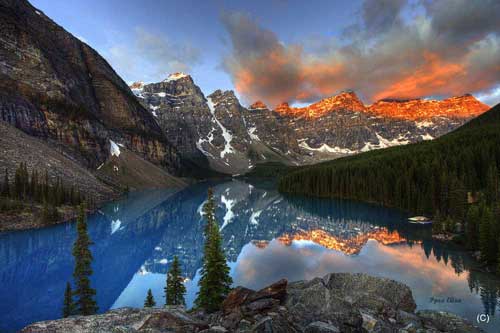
[{"xmin": 0, "ymin": 180, "xmax": 500, "ymax": 332}]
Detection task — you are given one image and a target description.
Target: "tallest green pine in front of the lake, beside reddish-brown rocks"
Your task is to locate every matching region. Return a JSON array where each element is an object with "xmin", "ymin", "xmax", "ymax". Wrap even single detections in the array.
[{"xmin": 195, "ymin": 189, "xmax": 233, "ymax": 312}]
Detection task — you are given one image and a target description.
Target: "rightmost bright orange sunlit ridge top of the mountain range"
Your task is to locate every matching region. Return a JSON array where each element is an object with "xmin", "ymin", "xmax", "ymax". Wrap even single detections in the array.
[{"xmin": 368, "ymin": 94, "xmax": 489, "ymax": 120}]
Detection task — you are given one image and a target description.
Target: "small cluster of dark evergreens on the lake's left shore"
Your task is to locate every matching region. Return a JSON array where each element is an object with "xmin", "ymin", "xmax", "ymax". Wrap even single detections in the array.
[{"xmin": 0, "ymin": 162, "xmax": 94, "ymax": 223}]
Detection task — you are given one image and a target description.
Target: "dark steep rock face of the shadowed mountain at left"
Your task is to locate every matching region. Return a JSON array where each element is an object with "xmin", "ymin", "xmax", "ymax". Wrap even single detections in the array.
[{"xmin": 0, "ymin": 0, "xmax": 179, "ymax": 170}]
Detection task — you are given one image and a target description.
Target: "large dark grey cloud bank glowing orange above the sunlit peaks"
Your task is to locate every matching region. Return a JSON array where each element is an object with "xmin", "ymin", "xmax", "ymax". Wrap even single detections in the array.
[{"xmin": 221, "ymin": 0, "xmax": 500, "ymax": 106}]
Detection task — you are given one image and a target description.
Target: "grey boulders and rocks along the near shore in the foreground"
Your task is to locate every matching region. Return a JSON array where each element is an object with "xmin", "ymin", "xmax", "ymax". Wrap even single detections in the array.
[{"xmin": 21, "ymin": 273, "xmax": 482, "ymax": 333}]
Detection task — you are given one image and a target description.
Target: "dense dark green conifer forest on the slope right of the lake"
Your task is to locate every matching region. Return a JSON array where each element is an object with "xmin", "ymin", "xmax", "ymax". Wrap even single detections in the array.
[{"xmin": 278, "ymin": 106, "xmax": 500, "ymax": 273}]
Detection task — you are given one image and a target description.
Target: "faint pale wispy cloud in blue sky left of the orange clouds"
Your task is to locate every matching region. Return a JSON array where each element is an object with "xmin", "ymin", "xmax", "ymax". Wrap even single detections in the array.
[{"xmin": 104, "ymin": 27, "xmax": 201, "ymax": 82}]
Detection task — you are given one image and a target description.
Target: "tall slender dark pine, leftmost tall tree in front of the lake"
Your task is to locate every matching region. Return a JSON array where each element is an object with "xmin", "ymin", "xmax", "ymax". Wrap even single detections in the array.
[{"xmin": 73, "ymin": 206, "xmax": 97, "ymax": 316}]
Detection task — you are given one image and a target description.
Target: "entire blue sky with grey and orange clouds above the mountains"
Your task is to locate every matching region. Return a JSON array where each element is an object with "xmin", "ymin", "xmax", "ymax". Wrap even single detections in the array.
[{"xmin": 31, "ymin": 0, "xmax": 500, "ymax": 106}]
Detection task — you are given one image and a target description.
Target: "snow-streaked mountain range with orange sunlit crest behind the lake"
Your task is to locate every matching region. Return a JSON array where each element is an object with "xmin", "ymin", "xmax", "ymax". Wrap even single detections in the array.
[{"xmin": 130, "ymin": 73, "xmax": 488, "ymax": 174}]
